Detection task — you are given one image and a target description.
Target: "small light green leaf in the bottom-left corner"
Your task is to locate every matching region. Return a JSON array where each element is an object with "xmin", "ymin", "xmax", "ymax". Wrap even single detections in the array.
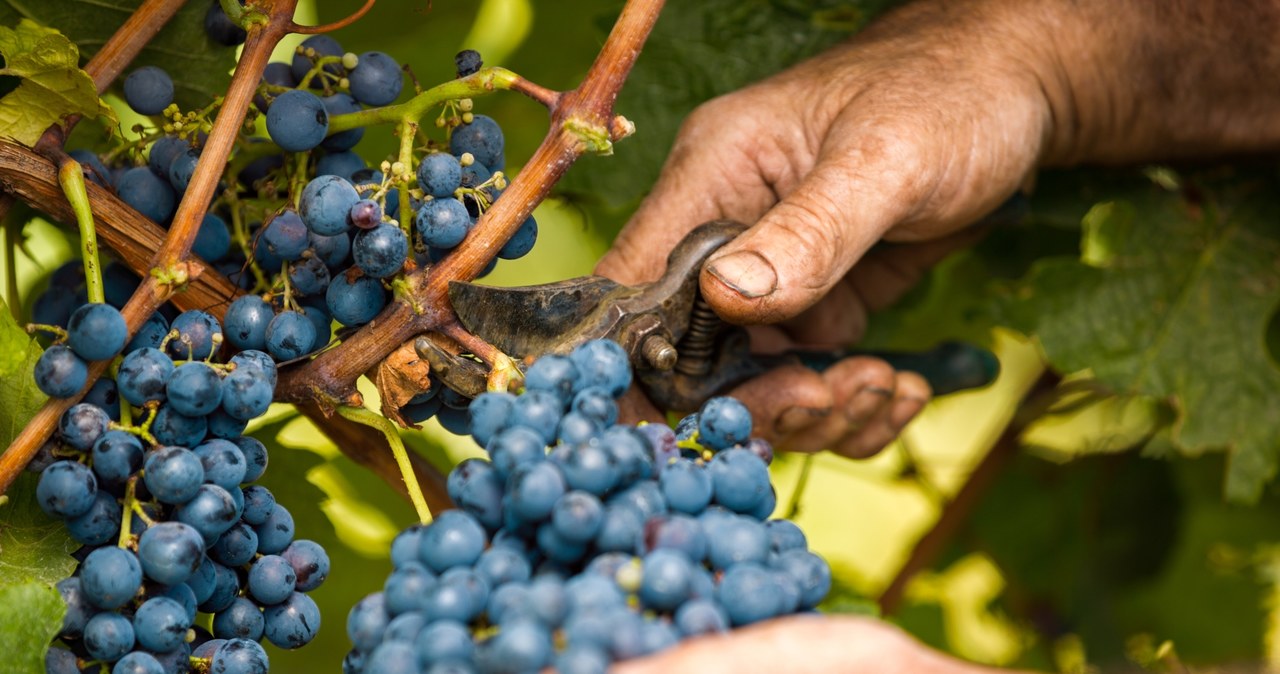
[{"xmin": 0, "ymin": 583, "xmax": 67, "ymax": 674}]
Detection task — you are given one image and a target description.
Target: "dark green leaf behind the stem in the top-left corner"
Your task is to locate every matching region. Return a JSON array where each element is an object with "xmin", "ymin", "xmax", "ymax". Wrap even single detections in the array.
[{"xmin": 0, "ymin": 0, "xmax": 236, "ymax": 109}]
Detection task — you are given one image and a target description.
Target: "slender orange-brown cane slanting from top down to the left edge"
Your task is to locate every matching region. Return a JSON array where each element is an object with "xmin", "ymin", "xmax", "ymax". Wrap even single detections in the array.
[{"xmin": 0, "ymin": 0, "xmax": 297, "ymax": 494}]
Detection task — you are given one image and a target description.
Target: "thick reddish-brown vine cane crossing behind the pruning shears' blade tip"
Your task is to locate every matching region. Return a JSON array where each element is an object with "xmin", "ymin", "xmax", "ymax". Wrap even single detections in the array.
[{"xmin": 276, "ymin": 0, "xmax": 663, "ymax": 408}]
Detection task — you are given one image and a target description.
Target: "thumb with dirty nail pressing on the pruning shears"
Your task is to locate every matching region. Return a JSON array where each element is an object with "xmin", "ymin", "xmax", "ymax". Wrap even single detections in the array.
[{"xmin": 701, "ymin": 143, "xmax": 922, "ymax": 325}]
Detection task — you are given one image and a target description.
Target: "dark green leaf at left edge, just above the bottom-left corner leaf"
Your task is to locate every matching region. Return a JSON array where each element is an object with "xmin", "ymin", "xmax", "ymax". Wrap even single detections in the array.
[{"xmin": 0, "ymin": 473, "xmax": 79, "ymax": 588}]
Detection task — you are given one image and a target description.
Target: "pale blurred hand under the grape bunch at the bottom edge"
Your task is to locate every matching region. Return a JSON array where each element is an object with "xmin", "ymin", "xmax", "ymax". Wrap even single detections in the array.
[{"xmin": 609, "ymin": 615, "xmax": 1018, "ymax": 674}]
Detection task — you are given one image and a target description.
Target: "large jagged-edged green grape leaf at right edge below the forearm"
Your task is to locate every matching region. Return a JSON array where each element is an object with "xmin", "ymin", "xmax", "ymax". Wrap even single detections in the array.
[{"xmin": 1009, "ymin": 176, "xmax": 1280, "ymax": 503}]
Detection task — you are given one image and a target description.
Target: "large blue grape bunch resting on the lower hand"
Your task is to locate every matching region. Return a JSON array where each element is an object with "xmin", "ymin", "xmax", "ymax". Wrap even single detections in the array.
[{"xmin": 343, "ymin": 340, "xmax": 831, "ymax": 674}]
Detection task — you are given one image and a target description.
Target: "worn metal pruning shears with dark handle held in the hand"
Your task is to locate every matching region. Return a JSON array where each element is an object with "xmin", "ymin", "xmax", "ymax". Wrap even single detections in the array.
[{"xmin": 416, "ymin": 220, "xmax": 998, "ymax": 412}]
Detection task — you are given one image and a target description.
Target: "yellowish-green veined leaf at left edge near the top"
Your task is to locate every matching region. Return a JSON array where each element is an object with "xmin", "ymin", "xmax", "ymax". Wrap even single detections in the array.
[{"xmin": 0, "ymin": 19, "xmax": 99, "ymax": 146}]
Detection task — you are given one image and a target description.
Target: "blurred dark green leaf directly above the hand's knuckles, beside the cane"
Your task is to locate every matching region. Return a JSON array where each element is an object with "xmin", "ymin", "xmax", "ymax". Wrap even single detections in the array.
[{"xmin": 559, "ymin": 0, "xmax": 892, "ymax": 221}]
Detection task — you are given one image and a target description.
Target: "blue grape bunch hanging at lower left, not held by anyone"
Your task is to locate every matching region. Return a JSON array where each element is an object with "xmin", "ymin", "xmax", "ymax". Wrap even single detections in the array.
[{"xmin": 28, "ymin": 304, "xmax": 329, "ymax": 674}]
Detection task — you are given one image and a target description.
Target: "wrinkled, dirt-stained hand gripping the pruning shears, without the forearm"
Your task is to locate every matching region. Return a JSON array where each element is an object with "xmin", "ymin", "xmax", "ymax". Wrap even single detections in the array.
[{"xmin": 598, "ymin": 0, "xmax": 1051, "ymax": 457}]
